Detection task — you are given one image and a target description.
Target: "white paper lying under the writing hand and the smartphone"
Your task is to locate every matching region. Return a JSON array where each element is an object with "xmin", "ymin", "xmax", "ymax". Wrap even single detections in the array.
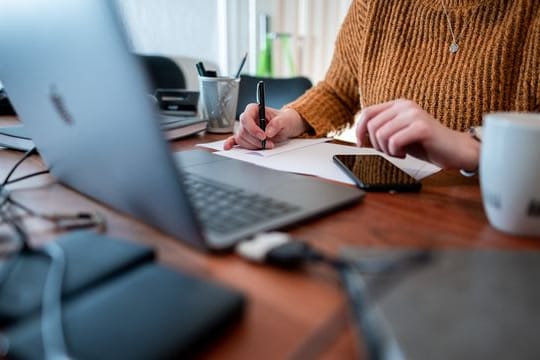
[{"xmin": 198, "ymin": 139, "xmax": 440, "ymax": 184}]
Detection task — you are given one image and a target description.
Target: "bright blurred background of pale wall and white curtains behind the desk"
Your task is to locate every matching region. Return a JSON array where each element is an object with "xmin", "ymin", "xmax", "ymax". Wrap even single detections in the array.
[{"xmin": 117, "ymin": 0, "xmax": 351, "ymax": 87}]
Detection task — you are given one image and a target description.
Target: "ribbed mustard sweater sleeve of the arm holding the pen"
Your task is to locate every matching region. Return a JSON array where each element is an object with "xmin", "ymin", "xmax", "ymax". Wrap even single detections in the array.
[{"xmin": 286, "ymin": 0, "xmax": 367, "ymax": 136}]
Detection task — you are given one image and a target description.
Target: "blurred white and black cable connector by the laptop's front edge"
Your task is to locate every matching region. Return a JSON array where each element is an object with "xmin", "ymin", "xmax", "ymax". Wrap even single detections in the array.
[{"xmin": 236, "ymin": 232, "xmax": 325, "ymax": 268}]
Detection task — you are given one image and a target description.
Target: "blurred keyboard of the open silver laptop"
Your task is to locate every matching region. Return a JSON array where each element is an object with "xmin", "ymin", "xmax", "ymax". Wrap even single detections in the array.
[{"xmin": 184, "ymin": 174, "xmax": 299, "ymax": 233}]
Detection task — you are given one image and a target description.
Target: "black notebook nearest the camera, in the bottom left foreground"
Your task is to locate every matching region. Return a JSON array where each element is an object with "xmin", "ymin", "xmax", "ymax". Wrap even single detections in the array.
[{"xmin": 3, "ymin": 263, "xmax": 244, "ymax": 360}]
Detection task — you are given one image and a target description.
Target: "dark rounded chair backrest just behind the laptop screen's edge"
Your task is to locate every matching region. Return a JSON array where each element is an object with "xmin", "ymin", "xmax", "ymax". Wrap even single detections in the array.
[{"xmin": 138, "ymin": 54, "xmax": 186, "ymax": 89}]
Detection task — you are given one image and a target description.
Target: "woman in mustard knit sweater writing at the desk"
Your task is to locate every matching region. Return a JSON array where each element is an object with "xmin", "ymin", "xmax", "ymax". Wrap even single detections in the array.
[{"xmin": 225, "ymin": 0, "xmax": 540, "ymax": 174}]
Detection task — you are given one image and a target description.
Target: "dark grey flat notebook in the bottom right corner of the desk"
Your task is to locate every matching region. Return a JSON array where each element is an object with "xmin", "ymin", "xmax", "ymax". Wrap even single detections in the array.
[{"xmin": 348, "ymin": 249, "xmax": 540, "ymax": 360}]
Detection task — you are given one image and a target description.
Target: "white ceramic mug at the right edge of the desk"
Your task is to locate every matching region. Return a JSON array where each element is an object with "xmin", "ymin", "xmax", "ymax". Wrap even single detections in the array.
[{"xmin": 480, "ymin": 112, "xmax": 540, "ymax": 236}]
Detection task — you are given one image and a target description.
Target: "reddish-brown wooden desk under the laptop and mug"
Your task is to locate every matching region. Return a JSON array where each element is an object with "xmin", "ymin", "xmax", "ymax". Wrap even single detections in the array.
[{"xmin": 0, "ymin": 119, "xmax": 540, "ymax": 359}]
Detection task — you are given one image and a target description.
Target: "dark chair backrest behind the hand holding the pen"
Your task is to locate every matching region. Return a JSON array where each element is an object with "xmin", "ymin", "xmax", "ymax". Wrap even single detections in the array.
[{"xmin": 236, "ymin": 75, "xmax": 312, "ymax": 119}]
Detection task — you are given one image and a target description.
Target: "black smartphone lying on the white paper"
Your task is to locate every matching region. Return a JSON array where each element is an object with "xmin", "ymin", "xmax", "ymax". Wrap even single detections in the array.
[{"xmin": 333, "ymin": 155, "xmax": 422, "ymax": 192}]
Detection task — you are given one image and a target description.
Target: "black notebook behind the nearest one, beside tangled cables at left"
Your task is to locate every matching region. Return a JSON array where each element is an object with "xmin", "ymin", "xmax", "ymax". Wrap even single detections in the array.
[{"xmin": 0, "ymin": 231, "xmax": 154, "ymax": 325}]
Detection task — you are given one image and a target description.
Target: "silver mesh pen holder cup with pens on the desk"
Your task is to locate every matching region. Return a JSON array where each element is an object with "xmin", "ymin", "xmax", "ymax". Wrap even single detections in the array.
[{"xmin": 199, "ymin": 76, "xmax": 240, "ymax": 133}]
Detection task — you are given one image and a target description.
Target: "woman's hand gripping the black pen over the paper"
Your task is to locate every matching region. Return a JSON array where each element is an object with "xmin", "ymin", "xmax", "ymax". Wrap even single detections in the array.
[{"xmin": 223, "ymin": 104, "xmax": 309, "ymax": 150}]
